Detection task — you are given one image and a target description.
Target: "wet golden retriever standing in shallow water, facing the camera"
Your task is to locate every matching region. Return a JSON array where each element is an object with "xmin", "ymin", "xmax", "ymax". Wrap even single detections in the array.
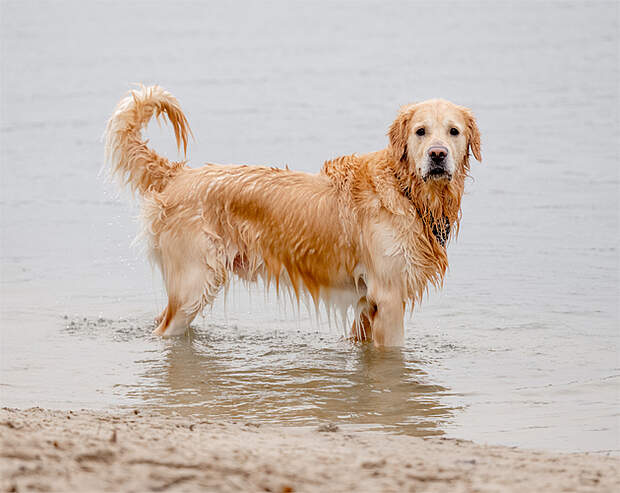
[{"xmin": 105, "ymin": 86, "xmax": 481, "ymax": 346}]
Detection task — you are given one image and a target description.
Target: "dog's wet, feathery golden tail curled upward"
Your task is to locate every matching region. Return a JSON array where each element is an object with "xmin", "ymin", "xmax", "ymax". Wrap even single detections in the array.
[{"xmin": 105, "ymin": 86, "xmax": 192, "ymax": 195}]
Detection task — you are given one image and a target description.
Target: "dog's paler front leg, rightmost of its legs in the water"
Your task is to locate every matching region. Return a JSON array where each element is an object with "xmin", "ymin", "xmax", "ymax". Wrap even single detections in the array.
[{"xmin": 371, "ymin": 292, "xmax": 405, "ymax": 347}]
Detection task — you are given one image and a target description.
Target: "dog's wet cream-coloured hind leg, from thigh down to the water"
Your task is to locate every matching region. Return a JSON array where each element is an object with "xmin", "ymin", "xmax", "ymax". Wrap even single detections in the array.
[{"xmin": 153, "ymin": 233, "xmax": 227, "ymax": 337}]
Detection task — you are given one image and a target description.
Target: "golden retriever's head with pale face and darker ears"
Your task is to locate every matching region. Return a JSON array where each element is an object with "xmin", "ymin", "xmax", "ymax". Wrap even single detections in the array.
[{"xmin": 388, "ymin": 99, "xmax": 482, "ymax": 185}]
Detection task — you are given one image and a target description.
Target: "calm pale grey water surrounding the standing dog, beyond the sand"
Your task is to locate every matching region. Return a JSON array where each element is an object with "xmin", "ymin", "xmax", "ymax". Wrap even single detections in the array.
[{"xmin": 0, "ymin": 2, "xmax": 620, "ymax": 452}]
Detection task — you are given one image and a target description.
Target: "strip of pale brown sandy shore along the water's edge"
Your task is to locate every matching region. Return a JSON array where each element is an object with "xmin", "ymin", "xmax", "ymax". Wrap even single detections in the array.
[{"xmin": 0, "ymin": 408, "xmax": 620, "ymax": 493}]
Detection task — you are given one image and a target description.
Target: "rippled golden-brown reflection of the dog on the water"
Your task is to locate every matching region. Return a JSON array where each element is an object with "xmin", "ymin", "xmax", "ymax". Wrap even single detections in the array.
[{"xmin": 129, "ymin": 326, "xmax": 452, "ymax": 435}]
